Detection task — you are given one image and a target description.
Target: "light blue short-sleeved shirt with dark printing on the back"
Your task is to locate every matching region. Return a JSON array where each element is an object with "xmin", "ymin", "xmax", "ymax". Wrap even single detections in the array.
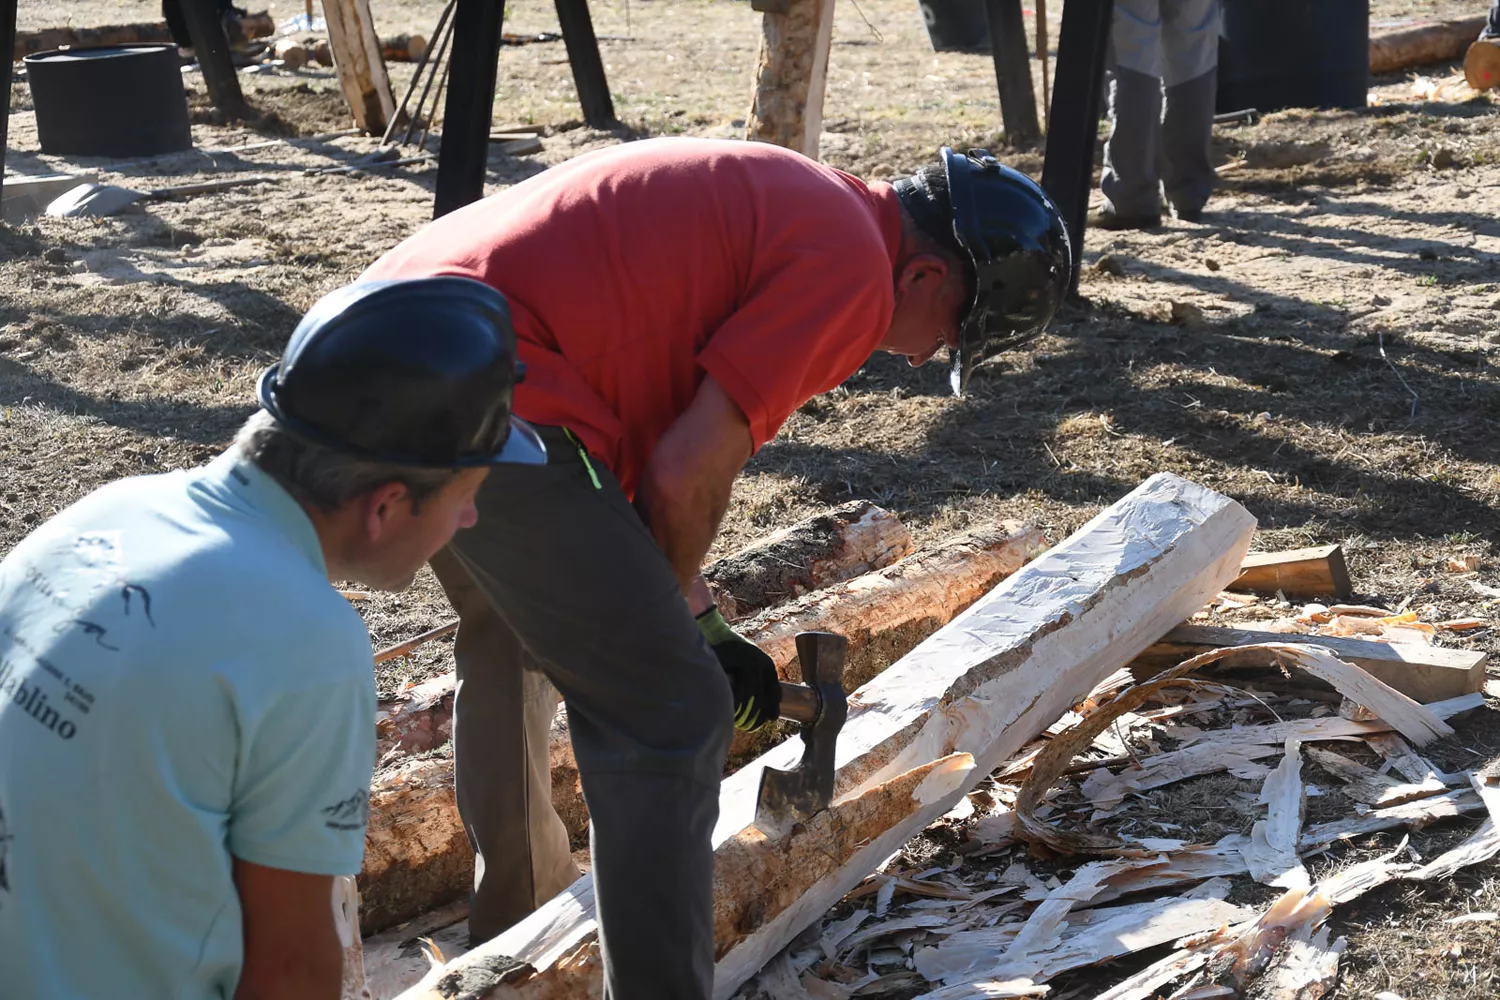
[{"xmin": 0, "ymin": 451, "xmax": 375, "ymax": 1000}]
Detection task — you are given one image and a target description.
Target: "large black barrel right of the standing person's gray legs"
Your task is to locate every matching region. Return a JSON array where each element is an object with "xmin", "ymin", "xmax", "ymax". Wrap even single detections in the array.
[{"xmin": 1218, "ymin": 0, "xmax": 1370, "ymax": 112}]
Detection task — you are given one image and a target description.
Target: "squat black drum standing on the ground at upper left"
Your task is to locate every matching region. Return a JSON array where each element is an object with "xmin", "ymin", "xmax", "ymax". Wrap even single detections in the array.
[{"xmin": 26, "ymin": 45, "xmax": 192, "ymax": 156}]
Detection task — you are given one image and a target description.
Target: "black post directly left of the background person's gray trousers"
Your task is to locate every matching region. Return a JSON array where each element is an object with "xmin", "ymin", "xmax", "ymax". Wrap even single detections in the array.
[{"xmin": 1041, "ymin": 0, "xmax": 1115, "ymax": 292}]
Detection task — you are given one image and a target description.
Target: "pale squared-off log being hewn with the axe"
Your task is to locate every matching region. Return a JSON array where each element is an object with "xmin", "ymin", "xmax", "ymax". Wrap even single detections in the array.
[{"xmin": 402, "ymin": 474, "xmax": 1254, "ymax": 1000}]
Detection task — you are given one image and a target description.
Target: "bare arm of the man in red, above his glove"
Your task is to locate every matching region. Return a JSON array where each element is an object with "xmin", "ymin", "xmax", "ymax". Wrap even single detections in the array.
[{"xmin": 636, "ymin": 376, "xmax": 752, "ymax": 615}]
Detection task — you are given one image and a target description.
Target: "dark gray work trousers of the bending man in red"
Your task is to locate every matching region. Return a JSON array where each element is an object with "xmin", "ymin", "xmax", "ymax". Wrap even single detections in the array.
[{"xmin": 432, "ymin": 427, "xmax": 734, "ymax": 1000}]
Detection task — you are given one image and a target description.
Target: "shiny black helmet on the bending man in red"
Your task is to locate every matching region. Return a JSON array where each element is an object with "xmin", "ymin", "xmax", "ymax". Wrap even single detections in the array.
[{"xmin": 896, "ymin": 145, "xmax": 1073, "ymax": 394}]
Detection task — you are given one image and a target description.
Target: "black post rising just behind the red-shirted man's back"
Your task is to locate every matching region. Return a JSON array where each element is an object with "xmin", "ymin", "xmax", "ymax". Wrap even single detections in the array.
[{"xmin": 432, "ymin": 0, "xmax": 506, "ymax": 219}]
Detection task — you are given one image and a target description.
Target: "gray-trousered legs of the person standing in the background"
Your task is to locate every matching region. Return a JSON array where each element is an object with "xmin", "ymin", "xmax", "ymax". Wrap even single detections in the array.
[{"xmin": 1100, "ymin": 0, "xmax": 1218, "ymax": 219}]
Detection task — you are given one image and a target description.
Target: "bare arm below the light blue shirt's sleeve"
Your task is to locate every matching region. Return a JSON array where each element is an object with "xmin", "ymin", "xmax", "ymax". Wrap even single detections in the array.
[{"xmin": 234, "ymin": 858, "xmax": 344, "ymax": 1000}]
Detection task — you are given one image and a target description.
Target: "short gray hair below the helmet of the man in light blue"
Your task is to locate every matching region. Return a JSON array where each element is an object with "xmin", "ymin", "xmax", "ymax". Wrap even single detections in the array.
[{"xmin": 234, "ymin": 409, "xmax": 459, "ymax": 511}]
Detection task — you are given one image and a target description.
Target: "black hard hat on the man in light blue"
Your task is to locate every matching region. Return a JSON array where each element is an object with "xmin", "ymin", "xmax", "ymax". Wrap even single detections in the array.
[{"xmin": 260, "ymin": 277, "xmax": 548, "ymax": 469}]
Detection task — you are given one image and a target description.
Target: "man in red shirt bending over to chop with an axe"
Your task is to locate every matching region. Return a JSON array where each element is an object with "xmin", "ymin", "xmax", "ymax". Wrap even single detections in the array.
[{"xmin": 365, "ymin": 139, "xmax": 1073, "ymax": 1000}]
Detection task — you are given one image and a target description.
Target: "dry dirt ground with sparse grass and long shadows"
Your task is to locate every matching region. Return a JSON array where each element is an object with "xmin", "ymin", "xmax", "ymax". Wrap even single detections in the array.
[{"xmin": 0, "ymin": 0, "xmax": 1500, "ymax": 1000}]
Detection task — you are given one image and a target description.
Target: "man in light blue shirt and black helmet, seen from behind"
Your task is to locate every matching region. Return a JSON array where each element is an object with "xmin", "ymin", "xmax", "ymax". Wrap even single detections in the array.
[{"xmin": 0, "ymin": 277, "xmax": 545, "ymax": 1000}]
